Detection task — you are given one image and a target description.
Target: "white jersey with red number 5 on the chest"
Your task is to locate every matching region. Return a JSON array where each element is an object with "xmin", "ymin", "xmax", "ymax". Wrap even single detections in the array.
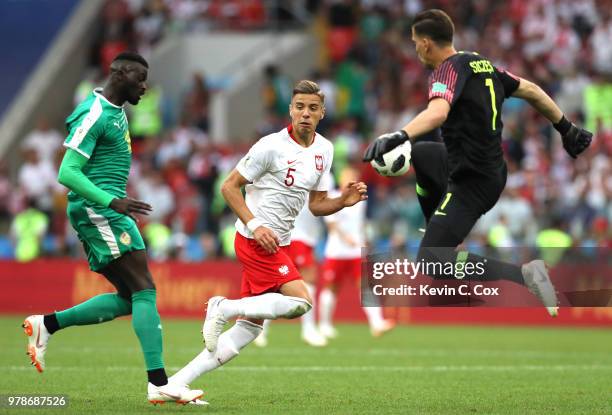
[{"xmin": 236, "ymin": 126, "xmax": 334, "ymax": 246}]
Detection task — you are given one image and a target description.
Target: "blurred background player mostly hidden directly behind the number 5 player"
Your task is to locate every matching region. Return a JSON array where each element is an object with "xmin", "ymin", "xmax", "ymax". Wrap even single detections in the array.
[{"xmin": 254, "ymin": 201, "xmax": 327, "ymax": 347}]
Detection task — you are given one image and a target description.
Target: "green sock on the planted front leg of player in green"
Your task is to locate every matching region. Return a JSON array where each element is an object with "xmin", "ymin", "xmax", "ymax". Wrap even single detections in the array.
[{"xmin": 132, "ymin": 290, "xmax": 164, "ymax": 370}]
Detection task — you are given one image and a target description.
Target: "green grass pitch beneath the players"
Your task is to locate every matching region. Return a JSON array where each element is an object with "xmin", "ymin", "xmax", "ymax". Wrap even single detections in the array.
[{"xmin": 0, "ymin": 316, "xmax": 612, "ymax": 415}]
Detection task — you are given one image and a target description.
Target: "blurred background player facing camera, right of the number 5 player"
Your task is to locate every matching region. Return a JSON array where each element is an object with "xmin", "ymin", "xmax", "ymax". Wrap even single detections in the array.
[{"xmin": 319, "ymin": 166, "xmax": 395, "ymax": 338}]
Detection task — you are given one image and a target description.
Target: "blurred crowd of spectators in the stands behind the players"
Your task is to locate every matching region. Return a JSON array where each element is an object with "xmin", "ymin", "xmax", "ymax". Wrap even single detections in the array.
[{"xmin": 0, "ymin": 0, "xmax": 612, "ymax": 261}]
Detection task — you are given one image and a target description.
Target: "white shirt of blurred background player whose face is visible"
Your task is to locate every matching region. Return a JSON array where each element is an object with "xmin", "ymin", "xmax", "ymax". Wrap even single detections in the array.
[{"xmin": 325, "ymin": 191, "xmax": 366, "ymax": 259}]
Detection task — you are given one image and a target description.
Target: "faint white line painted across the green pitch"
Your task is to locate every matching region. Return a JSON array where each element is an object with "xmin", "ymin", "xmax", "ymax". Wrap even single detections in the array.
[{"xmin": 5, "ymin": 364, "xmax": 612, "ymax": 372}]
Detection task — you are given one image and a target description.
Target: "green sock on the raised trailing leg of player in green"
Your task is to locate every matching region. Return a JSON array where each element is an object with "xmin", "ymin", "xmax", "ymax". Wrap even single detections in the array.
[{"xmin": 55, "ymin": 293, "xmax": 132, "ymax": 329}]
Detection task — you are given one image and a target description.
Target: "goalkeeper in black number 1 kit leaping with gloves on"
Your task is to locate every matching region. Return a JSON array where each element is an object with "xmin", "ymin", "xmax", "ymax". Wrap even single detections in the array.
[{"xmin": 363, "ymin": 9, "xmax": 592, "ymax": 316}]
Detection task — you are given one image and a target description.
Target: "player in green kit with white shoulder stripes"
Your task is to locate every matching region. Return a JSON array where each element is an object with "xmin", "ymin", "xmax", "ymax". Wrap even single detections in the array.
[{"xmin": 23, "ymin": 52, "xmax": 202, "ymax": 403}]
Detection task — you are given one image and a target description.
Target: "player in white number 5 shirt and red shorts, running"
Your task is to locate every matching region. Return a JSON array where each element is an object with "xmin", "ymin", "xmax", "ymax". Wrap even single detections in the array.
[{"xmin": 172, "ymin": 80, "xmax": 367, "ymax": 394}]
